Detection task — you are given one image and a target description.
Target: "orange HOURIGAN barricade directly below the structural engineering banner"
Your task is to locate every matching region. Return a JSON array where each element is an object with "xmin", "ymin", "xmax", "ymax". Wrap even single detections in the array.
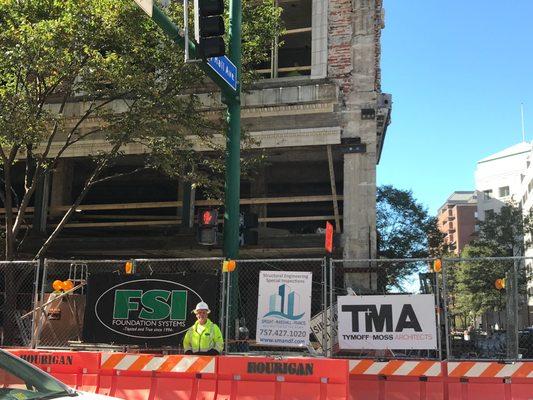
[{"xmin": 216, "ymin": 356, "xmax": 348, "ymax": 400}]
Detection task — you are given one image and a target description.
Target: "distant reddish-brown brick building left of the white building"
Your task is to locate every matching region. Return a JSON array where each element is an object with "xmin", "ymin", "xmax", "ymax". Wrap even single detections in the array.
[{"xmin": 437, "ymin": 191, "xmax": 477, "ymax": 255}]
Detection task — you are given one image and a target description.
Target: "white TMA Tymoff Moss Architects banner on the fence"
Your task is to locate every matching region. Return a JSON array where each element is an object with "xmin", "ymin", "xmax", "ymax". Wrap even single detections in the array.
[{"xmin": 337, "ymin": 294, "xmax": 437, "ymax": 350}]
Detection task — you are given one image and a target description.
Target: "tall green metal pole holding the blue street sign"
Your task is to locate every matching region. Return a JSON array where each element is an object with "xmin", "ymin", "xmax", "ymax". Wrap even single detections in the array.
[{"xmin": 224, "ymin": 0, "xmax": 242, "ymax": 259}]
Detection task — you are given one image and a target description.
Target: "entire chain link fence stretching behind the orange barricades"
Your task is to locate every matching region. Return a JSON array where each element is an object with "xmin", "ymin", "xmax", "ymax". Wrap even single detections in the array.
[{"xmin": 0, "ymin": 257, "xmax": 533, "ymax": 360}]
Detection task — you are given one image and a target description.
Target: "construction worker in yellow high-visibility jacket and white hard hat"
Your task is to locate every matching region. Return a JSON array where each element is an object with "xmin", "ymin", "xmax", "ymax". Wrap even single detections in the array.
[{"xmin": 183, "ymin": 301, "xmax": 224, "ymax": 355}]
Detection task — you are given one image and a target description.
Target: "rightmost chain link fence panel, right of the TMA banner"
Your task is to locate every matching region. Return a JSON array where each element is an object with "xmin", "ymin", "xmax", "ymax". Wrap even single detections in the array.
[{"xmin": 443, "ymin": 257, "xmax": 533, "ymax": 360}]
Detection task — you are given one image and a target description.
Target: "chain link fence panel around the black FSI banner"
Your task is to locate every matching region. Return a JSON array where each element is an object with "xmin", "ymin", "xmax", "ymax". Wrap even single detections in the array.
[{"xmin": 36, "ymin": 258, "xmax": 222, "ymax": 349}]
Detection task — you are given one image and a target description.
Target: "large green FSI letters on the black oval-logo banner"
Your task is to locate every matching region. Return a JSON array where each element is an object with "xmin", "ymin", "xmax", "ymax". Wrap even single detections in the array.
[{"xmin": 113, "ymin": 289, "xmax": 187, "ymax": 321}]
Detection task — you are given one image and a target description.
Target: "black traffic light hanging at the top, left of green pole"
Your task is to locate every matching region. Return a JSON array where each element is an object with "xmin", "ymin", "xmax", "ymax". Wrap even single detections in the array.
[{"xmin": 194, "ymin": 0, "xmax": 226, "ymax": 58}]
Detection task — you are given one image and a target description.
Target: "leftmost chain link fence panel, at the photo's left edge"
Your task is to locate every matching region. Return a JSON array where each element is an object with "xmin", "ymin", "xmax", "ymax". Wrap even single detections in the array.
[{"xmin": 0, "ymin": 261, "xmax": 39, "ymax": 346}]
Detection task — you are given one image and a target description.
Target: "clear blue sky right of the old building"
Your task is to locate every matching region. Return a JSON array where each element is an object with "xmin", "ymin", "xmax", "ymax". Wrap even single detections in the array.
[{"xmin": 377, "ymin": 0, "xmax": 533, "ymax": 214}]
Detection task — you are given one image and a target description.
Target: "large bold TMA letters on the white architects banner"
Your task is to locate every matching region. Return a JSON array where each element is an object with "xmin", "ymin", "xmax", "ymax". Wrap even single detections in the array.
[{"xmin": 341, "ymin": 304, "xmax": 422, "ymax": 332}]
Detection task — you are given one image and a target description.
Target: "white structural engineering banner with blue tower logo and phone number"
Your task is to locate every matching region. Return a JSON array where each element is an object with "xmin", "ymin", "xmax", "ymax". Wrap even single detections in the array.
[{"xmin": 256, "ymin": 271, "xmax": 312, "ymax": 347}]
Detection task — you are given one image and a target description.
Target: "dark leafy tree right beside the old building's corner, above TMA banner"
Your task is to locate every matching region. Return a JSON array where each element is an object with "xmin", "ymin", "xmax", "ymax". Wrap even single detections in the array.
[{"xmin": 376, "ymin": 185, "xmax": 444, "ymax": 287}]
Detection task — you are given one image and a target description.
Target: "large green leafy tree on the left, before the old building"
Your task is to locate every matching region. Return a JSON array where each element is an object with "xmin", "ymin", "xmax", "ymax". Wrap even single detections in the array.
[{"xmin": 0, "ymin": 0, "xmax": 280, "ymax": 260}]
